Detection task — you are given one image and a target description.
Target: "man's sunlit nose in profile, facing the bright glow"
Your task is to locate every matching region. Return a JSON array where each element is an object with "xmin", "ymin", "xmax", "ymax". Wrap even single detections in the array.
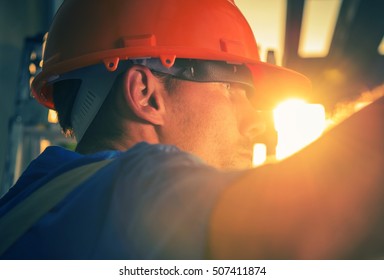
[{"xmin": 239, "ymin": 99, "xmax": 266, "ymax": 142}]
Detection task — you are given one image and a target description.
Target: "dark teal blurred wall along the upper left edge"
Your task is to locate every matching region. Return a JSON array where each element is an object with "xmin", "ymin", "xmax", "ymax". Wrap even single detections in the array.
[{"xmin": 0, "ymin": 0, "xmax": 56, "ymax": 190}]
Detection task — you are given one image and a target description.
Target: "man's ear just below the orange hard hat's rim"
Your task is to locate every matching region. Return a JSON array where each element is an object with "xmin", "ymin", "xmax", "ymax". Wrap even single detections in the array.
[{"xmin": 124, "ymin": 65, "xmax": 165, "ymax": 125}]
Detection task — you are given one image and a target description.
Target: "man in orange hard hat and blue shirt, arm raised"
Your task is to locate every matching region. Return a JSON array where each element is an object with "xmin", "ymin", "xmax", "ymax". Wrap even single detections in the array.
[{"xmin": 0, "ymin": 0, "xmax": 384, "ymax": 259}]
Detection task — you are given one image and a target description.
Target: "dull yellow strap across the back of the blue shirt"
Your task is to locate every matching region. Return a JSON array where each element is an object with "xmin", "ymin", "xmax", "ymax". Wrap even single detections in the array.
[{"xmin": 0, "ymin": 159, "xmax": 112, "ymax": 255}]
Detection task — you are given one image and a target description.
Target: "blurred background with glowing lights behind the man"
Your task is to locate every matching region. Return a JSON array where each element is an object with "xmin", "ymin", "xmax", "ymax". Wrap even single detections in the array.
[{"xmin": 0, "ymin": 0, "xmax": 384, "ymax": 196}]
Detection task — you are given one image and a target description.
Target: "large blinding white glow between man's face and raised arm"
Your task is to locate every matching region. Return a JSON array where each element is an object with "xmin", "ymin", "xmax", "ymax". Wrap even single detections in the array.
[{"xmin": 273, "ymin": 99, "xmax": 325, "ymax": 160}]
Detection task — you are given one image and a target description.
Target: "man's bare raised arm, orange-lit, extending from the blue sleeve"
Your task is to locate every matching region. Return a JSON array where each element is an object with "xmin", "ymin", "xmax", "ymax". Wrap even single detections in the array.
[{"xmin": 209, "ymin": 98, "xmax": 384, "ymax": 259}]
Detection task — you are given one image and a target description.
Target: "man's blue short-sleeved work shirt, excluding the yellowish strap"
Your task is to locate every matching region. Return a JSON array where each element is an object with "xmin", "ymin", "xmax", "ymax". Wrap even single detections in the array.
[{"xmin": 0, "ymin": 143, "xmax": 238, "ymax": 259}]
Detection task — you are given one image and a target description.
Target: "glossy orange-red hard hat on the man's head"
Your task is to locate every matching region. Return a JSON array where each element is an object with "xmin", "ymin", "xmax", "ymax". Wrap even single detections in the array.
[{"xmin": 32, "ymin": 0, "xmax": 309, "ymax": 108}]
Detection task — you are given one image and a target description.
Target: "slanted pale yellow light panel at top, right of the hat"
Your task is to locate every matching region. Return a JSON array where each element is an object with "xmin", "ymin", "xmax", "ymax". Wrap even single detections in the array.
[{"xmin": 298, "ymin": 0, "xmax": 342, "ymax": 57}]
